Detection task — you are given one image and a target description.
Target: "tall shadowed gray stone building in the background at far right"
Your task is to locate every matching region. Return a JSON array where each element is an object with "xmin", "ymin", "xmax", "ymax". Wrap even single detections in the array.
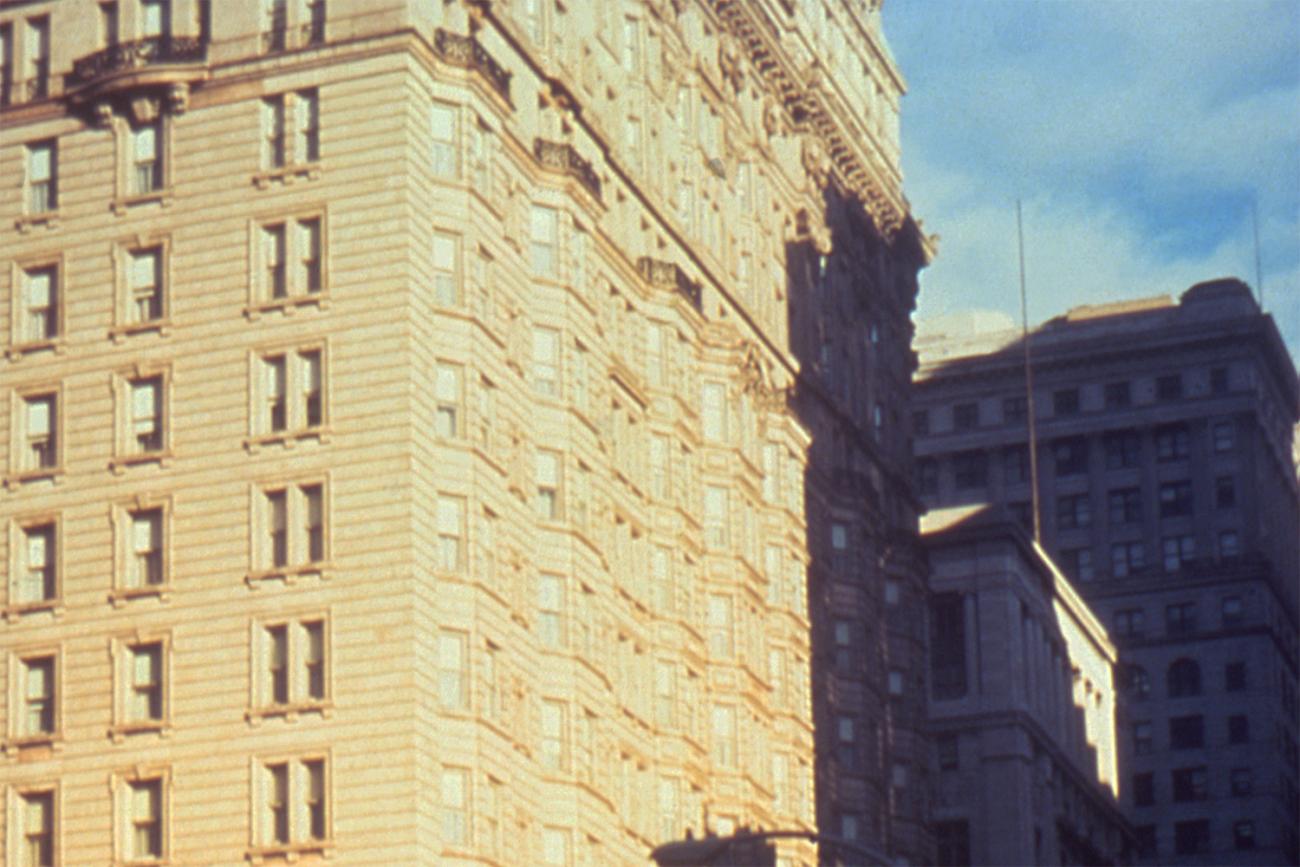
[{"xmin": 913, "ymin": 279, "xmax": 1300, "ymax": 864}]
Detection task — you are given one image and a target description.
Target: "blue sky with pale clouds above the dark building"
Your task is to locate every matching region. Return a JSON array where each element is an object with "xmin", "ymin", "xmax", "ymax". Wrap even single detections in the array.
[{"xmin": 884, "ymin": 0, "xmax": 1300, "ymax": 361}]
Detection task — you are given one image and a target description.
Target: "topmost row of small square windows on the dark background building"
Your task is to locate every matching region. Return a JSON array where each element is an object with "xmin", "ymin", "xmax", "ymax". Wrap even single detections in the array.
[{"xmin": 913, "ymin": 367, "xmax": 1232, "ymax": 437}]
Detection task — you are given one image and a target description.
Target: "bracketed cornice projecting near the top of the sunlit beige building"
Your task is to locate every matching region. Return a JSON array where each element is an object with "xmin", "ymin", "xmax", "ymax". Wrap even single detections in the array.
[{"xmin": 709, "ymin": 0, "xmax": 915, "ymax": 240}]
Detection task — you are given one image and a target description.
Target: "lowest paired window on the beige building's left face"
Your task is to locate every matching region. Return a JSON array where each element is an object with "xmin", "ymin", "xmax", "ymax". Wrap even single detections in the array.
[{"xmin": 256, "ymin": 758, "xmax": 329, "ymax": 851}]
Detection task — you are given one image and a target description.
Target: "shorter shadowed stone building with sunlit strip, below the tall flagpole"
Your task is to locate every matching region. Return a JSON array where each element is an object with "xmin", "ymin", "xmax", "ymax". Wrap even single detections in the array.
[{"xmin": 922, "ymin": 507, "xmax": 1132, "ymax": 864}]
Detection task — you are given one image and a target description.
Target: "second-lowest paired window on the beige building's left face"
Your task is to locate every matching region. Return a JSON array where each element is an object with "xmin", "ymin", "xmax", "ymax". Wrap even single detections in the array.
[{"xmin": 254, "ymin": 617, "xmax": 329, "ymax": 716}]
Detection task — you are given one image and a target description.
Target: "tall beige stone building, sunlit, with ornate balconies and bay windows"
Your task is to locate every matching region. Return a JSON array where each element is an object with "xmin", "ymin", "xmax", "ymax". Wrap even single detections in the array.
[{"xmin": 0, "ymin": 0, "xmax": 930, "ymax": 866}]
